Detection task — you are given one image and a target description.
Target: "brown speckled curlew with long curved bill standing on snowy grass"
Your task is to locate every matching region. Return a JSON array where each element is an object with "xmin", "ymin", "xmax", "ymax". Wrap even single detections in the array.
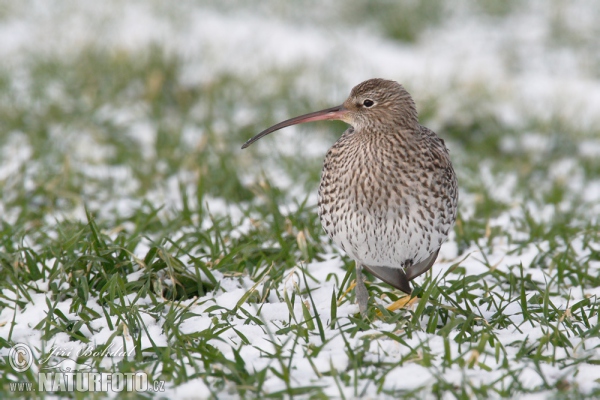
[{"xmin": 242, "ymin": 78, "xmax": 458, "ymax": 317}]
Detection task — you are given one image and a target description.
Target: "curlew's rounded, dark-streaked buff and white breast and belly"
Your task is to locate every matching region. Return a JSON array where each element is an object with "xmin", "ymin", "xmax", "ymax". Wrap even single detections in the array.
[{"xmin": 318, "ymin": 129, "xmax": 457, "ymax": 268}]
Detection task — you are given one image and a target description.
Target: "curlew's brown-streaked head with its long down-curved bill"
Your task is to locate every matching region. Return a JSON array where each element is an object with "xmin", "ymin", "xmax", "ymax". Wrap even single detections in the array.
[{"xmin": 242, "ymin": 79, "xmax": 418, "ymax": 149}]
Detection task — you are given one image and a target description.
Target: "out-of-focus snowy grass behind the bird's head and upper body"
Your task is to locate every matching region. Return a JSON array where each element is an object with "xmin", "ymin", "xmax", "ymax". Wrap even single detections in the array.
[{"xmin": 0, "ymin": 0, "xmax": 600, "ymax": 225}]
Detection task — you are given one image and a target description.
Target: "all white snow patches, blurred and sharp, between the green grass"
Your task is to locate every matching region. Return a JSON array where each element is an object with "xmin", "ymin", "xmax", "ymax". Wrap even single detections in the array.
[{"xmin": 0, "ymin": 1, "xmax": 600, "ymax": 398}]
